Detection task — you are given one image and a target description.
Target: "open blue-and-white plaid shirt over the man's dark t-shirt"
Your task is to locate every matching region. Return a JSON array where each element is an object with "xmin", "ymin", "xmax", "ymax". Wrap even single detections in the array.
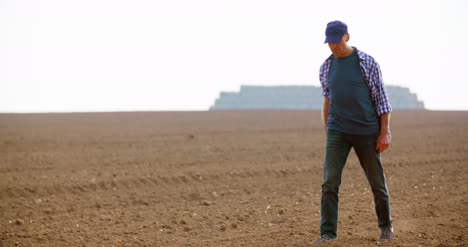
[{"xmin": 320, "ymin": 49, "xmax": 392, "ymax": 116}]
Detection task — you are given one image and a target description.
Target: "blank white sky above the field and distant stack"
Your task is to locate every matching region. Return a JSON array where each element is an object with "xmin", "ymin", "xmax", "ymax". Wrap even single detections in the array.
[{"xmin": 0, "ymin": 0, "xmax": 468, "ymax": 112}]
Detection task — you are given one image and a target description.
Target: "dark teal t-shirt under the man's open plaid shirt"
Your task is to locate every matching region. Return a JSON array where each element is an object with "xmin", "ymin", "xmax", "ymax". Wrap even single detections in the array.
[{"xmin": 328, "ymin": 49, "xmax": 379, "ymax": 135}]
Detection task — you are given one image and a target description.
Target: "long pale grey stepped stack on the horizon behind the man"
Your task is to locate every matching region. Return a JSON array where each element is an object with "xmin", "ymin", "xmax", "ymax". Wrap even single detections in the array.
[{"xmin": 210, "ymin": 85, "xmax": 424, "ymax": 110}]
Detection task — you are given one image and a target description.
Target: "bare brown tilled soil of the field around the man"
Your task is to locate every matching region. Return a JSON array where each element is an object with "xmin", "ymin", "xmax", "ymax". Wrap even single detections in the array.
[{"xmin": 0, "ymin": 111, "xmax": 468, "ymax": 247}]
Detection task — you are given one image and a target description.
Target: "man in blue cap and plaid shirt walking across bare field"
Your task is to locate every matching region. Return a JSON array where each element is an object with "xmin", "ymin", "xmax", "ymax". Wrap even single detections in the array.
[{"xmin": 317, "ymin": 21, "xmax": 394, "ymax": 243}]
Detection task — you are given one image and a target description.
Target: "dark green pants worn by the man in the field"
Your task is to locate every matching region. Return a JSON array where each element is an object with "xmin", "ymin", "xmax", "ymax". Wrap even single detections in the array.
[{"xmin": 320, "ymin": 131, "xmax": 392, "ymax": 237}]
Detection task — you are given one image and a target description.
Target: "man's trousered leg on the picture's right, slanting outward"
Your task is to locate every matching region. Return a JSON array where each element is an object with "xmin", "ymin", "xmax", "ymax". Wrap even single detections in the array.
[{"xmin": 353, "ymin": 135, "xmax": 392, "ymax": 229}]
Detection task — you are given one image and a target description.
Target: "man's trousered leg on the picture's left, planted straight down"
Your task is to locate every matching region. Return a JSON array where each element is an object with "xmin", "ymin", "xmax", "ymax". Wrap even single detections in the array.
[{"xmin": 320, "ymin": 131, "xmax": 351, "ymax": 237}]
